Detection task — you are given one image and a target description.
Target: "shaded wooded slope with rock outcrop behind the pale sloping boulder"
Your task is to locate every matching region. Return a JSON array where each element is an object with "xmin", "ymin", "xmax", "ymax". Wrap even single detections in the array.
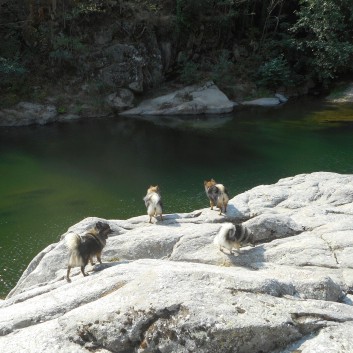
[{"xmin": 0, "ymin": 0, "xmax": 352, "ymax": 126}]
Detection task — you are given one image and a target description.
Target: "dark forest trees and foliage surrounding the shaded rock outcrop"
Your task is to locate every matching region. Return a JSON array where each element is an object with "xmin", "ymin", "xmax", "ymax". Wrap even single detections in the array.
[{"xmin": 0, "ymin": 0, "xmax": 353, "ymax": 107}]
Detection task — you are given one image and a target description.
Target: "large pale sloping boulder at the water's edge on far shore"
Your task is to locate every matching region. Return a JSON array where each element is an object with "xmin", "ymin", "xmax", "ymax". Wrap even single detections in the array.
[{"xmin": 121, "ymin": 81, "xmax": 235, "ymax": 115}]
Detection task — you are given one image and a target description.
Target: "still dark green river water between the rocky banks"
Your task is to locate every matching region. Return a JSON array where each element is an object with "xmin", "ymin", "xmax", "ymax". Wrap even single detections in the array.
[{"xmin": 0, "ymin": 97, "xmax": 353, "ymax": 297}]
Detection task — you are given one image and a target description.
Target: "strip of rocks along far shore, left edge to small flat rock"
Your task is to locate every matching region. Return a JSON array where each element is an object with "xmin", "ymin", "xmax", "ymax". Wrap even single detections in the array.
[{"xmin": 0, "ymin": 81, "xmax": 288, "ymax": 127}]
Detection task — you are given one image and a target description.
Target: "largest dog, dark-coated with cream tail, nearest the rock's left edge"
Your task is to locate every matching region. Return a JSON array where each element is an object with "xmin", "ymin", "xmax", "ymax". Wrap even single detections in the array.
[{"xmin": 66, "ymin": 222, "xmax": 112, "ymax": 282}]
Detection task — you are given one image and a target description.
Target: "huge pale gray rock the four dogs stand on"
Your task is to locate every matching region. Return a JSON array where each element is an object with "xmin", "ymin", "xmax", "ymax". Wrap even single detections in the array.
[{"xmin": 0, "ymin": 172, "xmax": 353, "ymax": 353}]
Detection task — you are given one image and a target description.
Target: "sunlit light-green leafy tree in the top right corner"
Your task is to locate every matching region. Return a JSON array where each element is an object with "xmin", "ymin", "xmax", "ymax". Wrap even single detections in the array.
[{"xmin": 291, "ymin": 0, "xmax": 353, "ymax": 84}]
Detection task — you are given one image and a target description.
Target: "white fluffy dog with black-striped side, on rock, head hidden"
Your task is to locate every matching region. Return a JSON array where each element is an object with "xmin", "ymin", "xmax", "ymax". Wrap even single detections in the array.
[{"xmin": 213, "ymin": 223, "xmax": 254, "ymax": 253}]
